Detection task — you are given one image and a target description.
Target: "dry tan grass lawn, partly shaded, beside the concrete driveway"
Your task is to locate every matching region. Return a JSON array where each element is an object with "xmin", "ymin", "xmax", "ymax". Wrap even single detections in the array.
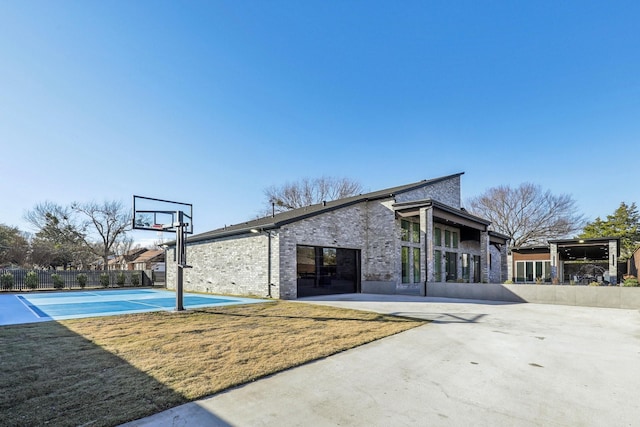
[{"xmin": 0, "ymin": 301, "xmax": 425, "ymax": 426}]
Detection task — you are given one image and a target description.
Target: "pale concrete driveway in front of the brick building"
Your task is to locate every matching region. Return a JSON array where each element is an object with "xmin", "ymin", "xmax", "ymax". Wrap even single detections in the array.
[{"xmin": 122, "ymin": 294, "xmax": 640, "ymax": 426}]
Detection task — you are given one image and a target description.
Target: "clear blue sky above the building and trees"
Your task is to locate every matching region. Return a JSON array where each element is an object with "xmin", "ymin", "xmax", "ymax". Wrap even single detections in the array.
[{"xmin": 0, "ymin": 0, "xmax": 640, "ymax": 244}]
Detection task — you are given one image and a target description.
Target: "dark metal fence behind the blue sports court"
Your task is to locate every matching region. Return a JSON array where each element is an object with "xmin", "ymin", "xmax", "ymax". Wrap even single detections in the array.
[{"xmin": 0, "ymin": 269, "xmax": 153, "ymax": 291}]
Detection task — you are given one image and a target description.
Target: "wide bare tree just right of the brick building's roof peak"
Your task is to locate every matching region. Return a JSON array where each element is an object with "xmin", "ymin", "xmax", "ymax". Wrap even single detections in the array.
[{"xmin": 467, "ymin": 183, "xmax": 585, "ymax": 248}]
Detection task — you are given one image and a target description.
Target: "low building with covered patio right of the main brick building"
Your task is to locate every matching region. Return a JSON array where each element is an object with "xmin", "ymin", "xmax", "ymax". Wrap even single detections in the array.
[{"xmin": 510, "ymin": 237, "xmax": 620, "ymax": 285}]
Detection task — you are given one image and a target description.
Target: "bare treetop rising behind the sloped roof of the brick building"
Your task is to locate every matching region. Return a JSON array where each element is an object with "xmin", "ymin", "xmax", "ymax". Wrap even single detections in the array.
[{"xmin": 264, "ymin": 177, "xmax": 362, "ymax": 212}]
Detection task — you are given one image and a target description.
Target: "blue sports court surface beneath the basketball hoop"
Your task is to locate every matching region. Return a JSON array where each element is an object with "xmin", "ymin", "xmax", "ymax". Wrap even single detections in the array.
[{"xmin": 0, "ymin": 289, "xmax": 267, "ymax": 326}]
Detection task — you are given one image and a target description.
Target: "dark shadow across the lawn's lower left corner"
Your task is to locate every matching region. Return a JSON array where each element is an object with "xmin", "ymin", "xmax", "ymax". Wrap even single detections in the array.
[{"xmin": 0, "ymin": 322, "xmax": 227, "ymax": 426}]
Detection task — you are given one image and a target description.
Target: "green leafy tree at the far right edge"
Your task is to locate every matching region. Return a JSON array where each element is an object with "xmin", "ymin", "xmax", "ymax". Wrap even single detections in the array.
[{"xmin": 578, "ymin": 202, "xmax": 640, "ymax": 260}]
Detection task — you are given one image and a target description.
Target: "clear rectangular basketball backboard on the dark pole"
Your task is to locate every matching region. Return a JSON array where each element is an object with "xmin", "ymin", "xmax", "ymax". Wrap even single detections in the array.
[{"xmin": 133, "ymin": 196, "xmax": 193, "ymax": 234}]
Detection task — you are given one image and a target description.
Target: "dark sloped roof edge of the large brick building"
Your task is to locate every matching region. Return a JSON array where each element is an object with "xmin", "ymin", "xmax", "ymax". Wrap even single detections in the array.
[{"xmin": 182, "ymin": 172, "xmax": 464, "ymax": 246}]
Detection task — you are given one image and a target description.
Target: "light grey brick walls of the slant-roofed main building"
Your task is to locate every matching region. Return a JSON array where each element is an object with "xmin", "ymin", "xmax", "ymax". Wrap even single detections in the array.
[{"xmin": 167, "ymin": 172, "xmax": 504, "ymax": 299}]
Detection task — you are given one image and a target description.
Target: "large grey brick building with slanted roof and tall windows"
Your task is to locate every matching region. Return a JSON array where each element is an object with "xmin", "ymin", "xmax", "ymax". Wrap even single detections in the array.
[{"xmin": 167, "ymin": 173, "xmax": 508, "ymax": 299}]
